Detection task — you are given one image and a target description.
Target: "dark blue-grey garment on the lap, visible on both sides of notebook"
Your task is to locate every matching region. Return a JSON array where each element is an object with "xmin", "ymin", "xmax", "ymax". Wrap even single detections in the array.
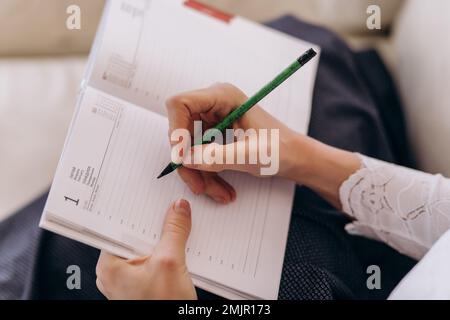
[{"xmin": 0, "ymin": 17, "xmax": 414, "ymax": 299}]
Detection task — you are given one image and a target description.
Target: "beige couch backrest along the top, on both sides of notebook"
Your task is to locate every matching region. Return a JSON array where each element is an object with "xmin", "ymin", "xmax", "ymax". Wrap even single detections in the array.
[{"xmin": 0, "ymin": 0, "xmax": 403, "ymax": 55}]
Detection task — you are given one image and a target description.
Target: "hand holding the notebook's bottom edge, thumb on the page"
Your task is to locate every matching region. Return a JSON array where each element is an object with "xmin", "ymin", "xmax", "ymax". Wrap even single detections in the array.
[{"xmin": 96, "ymin": 200, "xmax": 197, "ymax": 300}]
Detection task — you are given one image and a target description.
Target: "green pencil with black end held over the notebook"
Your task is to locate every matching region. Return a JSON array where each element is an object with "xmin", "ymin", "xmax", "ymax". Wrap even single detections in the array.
[{"xmin": 158, "ymin": 49, "xmax": 317, "ymax": 179}]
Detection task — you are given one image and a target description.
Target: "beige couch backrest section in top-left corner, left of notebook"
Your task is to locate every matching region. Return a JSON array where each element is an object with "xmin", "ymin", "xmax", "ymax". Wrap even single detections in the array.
[{"xmin": 0, "ymin": 0, "xmax": 104, "ymax": 55}]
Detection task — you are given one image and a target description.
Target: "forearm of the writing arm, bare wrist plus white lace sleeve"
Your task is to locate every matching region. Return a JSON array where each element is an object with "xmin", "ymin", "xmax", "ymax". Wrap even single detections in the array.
[{"xmin": 291, "ymin": 138, "xmax": 450, "ymax": 259}]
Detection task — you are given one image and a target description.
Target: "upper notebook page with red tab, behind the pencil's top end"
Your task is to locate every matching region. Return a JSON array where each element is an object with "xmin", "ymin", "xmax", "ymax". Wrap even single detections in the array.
[{"xmin": 90, "ymin": 0, "xmax": 320, "ymax": 133}]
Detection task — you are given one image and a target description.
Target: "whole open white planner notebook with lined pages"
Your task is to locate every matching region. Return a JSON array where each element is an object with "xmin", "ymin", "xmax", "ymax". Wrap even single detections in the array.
[{"xmin": 40, "ymin": 0, "xmax": 319, "ymax": 299}]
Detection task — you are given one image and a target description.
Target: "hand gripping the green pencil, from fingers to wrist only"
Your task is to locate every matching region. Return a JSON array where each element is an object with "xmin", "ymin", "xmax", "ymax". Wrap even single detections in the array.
[{"xmin": 167, "ymin": 84, "xmax": 304, "ymax": 204}]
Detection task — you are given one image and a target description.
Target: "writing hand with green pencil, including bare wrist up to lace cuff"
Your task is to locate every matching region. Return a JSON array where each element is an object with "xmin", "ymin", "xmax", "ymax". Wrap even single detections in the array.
[{"xmin": 167, "ymin": 84, "xmax": 361, "ymax": 209}]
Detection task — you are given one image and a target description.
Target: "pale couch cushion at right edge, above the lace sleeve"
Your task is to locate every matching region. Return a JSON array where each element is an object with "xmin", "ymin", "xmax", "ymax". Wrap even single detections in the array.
[{"xmin": 393, "ymin": 0, "xmax": 450, "ymax": 176}]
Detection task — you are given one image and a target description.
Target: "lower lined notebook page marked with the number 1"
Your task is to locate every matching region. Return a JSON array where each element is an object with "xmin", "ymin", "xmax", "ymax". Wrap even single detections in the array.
[{"xmin": 42, "ymin": 87, "xmax": 294, "ymax": 299}]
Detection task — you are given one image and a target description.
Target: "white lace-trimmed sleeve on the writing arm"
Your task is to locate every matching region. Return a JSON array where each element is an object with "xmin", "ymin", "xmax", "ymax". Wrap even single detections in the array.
[{"xmin": 340, "ymin": 156, "xmax": 450, "ymax": 259}]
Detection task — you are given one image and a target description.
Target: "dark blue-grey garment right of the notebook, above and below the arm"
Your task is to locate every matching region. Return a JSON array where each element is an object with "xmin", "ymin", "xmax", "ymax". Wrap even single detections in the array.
[{"xmin": 269, "ymin": 16, "xmax": 415, "ymax": 299}]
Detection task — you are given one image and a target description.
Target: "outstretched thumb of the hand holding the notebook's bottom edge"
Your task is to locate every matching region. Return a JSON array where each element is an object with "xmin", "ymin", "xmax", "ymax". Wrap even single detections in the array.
[{"xmin": 158, "ymin": 200, "xmax": 191, "ymax": 263}]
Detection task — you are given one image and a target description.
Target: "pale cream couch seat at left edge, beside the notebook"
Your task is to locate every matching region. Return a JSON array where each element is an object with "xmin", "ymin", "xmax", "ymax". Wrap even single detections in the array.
[{"xmin": 0, "ymin": 58, "xmax": 85, "ymax": 220}]
